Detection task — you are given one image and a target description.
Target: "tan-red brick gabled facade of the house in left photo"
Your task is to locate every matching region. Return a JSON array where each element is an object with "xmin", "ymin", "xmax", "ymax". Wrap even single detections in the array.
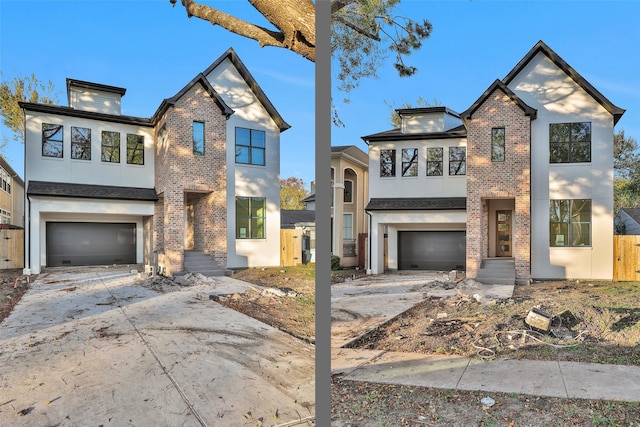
[{"xmin": 154, "ymin": 83, "xmax": 227, "ymax": 274}]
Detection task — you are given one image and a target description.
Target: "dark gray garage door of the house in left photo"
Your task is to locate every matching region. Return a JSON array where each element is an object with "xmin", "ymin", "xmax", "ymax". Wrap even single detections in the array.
[{"xmin": 47, "ymin": 222, "xmax": 136, "ymax": 267}]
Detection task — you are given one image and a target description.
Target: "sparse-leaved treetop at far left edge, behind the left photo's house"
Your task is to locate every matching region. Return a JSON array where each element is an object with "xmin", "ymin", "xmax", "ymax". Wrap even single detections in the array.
[{"xmin": 0, "ymin": 74, "xmax": 58, "ymax": 143}]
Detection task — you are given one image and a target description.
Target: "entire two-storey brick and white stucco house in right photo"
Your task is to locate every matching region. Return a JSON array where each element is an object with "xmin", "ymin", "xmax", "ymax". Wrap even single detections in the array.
[{"xmin": 363, "ymin": 41, "xmax": 624, "ymax": 283}]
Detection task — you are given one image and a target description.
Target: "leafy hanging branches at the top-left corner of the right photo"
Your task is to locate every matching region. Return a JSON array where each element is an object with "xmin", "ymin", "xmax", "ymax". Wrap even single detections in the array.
[{"xmin": 331, "ymin": 0, "xmax": 432, "ymax": 125}]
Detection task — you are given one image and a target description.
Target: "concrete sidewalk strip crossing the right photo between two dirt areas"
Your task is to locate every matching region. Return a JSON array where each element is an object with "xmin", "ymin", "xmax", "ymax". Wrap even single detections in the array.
[{"xmin": 331, "ymin": 348, "xmax": 640, "ymax": 402}]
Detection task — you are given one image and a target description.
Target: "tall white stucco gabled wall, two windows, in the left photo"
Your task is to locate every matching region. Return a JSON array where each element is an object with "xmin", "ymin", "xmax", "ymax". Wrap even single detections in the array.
[{"xmin": 207, "ymin": 55, "xmax": 280, "ymax": 268}]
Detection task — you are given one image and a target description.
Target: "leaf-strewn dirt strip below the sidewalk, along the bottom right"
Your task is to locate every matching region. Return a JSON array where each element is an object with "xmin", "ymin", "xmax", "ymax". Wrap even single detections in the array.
[{"xmin": 331, "ymin": 377, "xmax": 640, "ymax": 427}]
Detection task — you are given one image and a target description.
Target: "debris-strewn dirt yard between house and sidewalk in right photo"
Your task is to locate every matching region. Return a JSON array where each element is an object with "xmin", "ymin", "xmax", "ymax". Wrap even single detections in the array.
[{"xmin": 350, "ymin": 281, "xmax": 640, "ymax": 365}]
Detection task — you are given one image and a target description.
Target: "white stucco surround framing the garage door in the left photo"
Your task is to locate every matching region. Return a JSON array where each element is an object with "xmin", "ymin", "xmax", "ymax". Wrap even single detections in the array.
[{"xmin": 25, "ymin": 197, "xmax": 154, "ymax": 274}]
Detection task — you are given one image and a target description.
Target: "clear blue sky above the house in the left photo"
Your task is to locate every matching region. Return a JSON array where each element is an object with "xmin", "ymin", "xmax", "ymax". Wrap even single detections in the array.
[{"xmin": 0, "ymin": 0, "xmax": 315, "ymax": 188}]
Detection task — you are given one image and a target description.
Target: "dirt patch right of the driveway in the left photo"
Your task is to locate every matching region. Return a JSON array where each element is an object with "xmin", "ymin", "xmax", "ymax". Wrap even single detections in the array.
[{"xmin": 215, "ymin": 264, "xmax": 316, "ymax": 343}]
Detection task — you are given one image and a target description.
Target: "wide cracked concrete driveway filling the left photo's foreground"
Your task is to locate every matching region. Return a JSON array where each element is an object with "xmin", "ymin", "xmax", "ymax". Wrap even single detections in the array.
[{"xmin": 0, "ymin": 267, "xmax": 315, "ymax": 426}]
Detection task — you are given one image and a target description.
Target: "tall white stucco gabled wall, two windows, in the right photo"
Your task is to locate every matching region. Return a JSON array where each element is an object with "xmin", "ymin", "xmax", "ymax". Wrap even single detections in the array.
[{"xmin": 509, "ymin": 53, "xmax": 613, "ymax": 280}]
